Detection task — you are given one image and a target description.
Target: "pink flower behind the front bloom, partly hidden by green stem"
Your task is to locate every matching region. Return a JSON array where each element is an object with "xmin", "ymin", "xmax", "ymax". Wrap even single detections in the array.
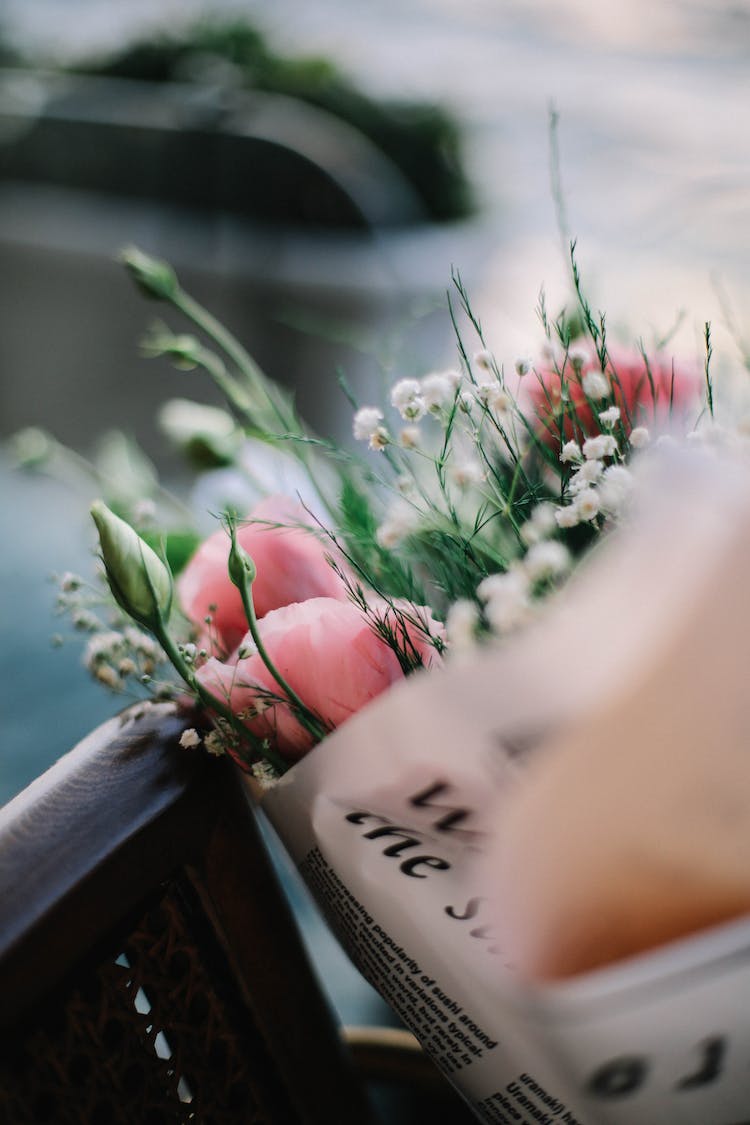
[{"xmin": 178, "ymin": 496, "xmax": 346, "ymax": 654}]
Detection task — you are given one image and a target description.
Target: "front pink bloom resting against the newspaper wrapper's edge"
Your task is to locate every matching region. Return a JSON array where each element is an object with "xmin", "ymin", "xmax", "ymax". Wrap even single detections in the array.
[{"xmin": 198, "ymin": 597, "xmax": 441, "ymax": 758}]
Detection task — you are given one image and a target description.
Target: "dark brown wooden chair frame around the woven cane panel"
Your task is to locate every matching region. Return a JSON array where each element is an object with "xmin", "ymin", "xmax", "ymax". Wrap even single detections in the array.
[{"xmin": 0, "ymin": 707, "xmax": 370, "ymax": 1125}]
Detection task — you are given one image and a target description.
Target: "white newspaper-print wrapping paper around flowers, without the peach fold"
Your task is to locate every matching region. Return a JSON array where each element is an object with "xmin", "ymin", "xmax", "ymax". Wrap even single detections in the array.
[{"xmin": 263, "ymin": 458, "xmax": 750, "ymax": 1125}]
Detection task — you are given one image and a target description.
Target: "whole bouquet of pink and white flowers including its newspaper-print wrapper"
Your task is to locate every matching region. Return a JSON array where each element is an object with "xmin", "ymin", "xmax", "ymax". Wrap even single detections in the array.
[{"xmin": 29, "ymin": 246, "xmax": 750, "ymax": 1125}]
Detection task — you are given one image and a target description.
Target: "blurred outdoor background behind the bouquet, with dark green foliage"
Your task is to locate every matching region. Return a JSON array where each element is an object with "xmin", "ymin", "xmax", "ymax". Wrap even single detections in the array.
[{"xmin": 0, "ymin": 0, "xmax": 750, "ymax": 1030}]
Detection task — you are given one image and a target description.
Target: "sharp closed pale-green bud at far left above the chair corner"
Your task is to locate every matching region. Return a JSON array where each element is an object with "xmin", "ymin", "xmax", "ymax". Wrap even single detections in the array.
[{"xmin": 91, "ymin": 501, "xmax": 172, "ymax": 630}]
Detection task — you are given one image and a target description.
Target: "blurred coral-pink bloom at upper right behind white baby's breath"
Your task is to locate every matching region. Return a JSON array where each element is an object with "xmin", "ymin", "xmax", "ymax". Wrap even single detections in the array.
[{"xmin": 528, "ymin": 348, "xmax": 699, "ymax": 448}]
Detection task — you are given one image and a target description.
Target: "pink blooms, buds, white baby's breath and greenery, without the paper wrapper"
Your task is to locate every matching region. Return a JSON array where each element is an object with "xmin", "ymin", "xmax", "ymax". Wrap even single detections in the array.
[{"xmin": 52, "ymin": 250, "xmax": 699, "ymax": 777}]
